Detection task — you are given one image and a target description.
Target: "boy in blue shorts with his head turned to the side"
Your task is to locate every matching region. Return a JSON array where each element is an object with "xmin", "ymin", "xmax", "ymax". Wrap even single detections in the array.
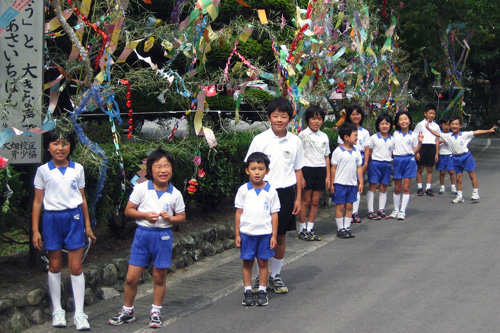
[{"xmin": 330, "ymin": 123, "xmax": 363, "ymax": 238}]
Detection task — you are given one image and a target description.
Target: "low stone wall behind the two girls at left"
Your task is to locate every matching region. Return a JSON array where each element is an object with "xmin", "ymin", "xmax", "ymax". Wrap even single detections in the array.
[{"xmin": 0, "ymin": 222, "xmax": 234, "ymax": 332}]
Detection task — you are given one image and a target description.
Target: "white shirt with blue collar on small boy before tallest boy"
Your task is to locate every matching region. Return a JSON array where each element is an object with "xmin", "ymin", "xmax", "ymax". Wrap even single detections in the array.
[{"xmin": 234, "ymin": 182, "xmax": 281, "ymax": 236}]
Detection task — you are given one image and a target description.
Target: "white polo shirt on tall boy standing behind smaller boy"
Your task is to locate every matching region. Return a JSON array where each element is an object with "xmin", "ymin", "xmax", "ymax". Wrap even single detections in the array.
[{"xmin": 245, "ymin": 128, "xmax": 305, "ymax": 189}]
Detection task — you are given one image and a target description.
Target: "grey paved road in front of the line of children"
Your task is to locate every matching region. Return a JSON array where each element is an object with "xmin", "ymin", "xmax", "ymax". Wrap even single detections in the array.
[{"xmin": 29, "ymin": 139, "xmax": 500, "ymax": 333}]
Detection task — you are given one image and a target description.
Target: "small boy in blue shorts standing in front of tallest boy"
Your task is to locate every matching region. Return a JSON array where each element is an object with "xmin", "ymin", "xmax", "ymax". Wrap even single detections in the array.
[{"xmin": 234, "ymin": 152, "xmax": 280, "ymax": 306}]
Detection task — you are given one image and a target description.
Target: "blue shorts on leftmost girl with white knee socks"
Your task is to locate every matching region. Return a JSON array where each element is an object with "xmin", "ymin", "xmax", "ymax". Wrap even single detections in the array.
[{"xmin": 43, "ymin": 206, "xmax": 85, "ymax": 251}]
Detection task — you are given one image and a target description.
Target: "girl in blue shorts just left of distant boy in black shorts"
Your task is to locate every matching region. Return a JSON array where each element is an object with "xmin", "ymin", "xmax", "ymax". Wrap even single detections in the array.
[{"xmin": 389, "ymin": 111, "xmax": 424, "ymax": 220}]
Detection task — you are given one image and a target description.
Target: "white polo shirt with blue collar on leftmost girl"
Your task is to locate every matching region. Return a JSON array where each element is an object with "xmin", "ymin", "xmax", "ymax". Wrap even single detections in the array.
[{"xmin": 34, "ymin": 161, "xmax": 85, "ymax": 210}]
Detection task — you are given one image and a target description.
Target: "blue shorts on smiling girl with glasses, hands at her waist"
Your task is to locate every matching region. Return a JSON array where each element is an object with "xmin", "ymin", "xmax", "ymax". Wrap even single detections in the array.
[{"xmin": 128, "ymin": 225, "xmax": 174, "ymax": 268}]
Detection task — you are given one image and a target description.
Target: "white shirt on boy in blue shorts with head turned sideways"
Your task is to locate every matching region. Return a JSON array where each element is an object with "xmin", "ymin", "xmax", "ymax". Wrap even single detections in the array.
[{"xmin": 331, "ymin": 146, "xmax": 363, "ymax": 186}]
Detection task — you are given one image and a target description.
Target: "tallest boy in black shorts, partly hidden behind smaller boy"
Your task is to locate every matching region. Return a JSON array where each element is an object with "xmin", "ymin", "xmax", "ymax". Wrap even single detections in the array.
[{"xmin": 245, "ymin": 97, "xmax": 304, "ymax": 294}]
